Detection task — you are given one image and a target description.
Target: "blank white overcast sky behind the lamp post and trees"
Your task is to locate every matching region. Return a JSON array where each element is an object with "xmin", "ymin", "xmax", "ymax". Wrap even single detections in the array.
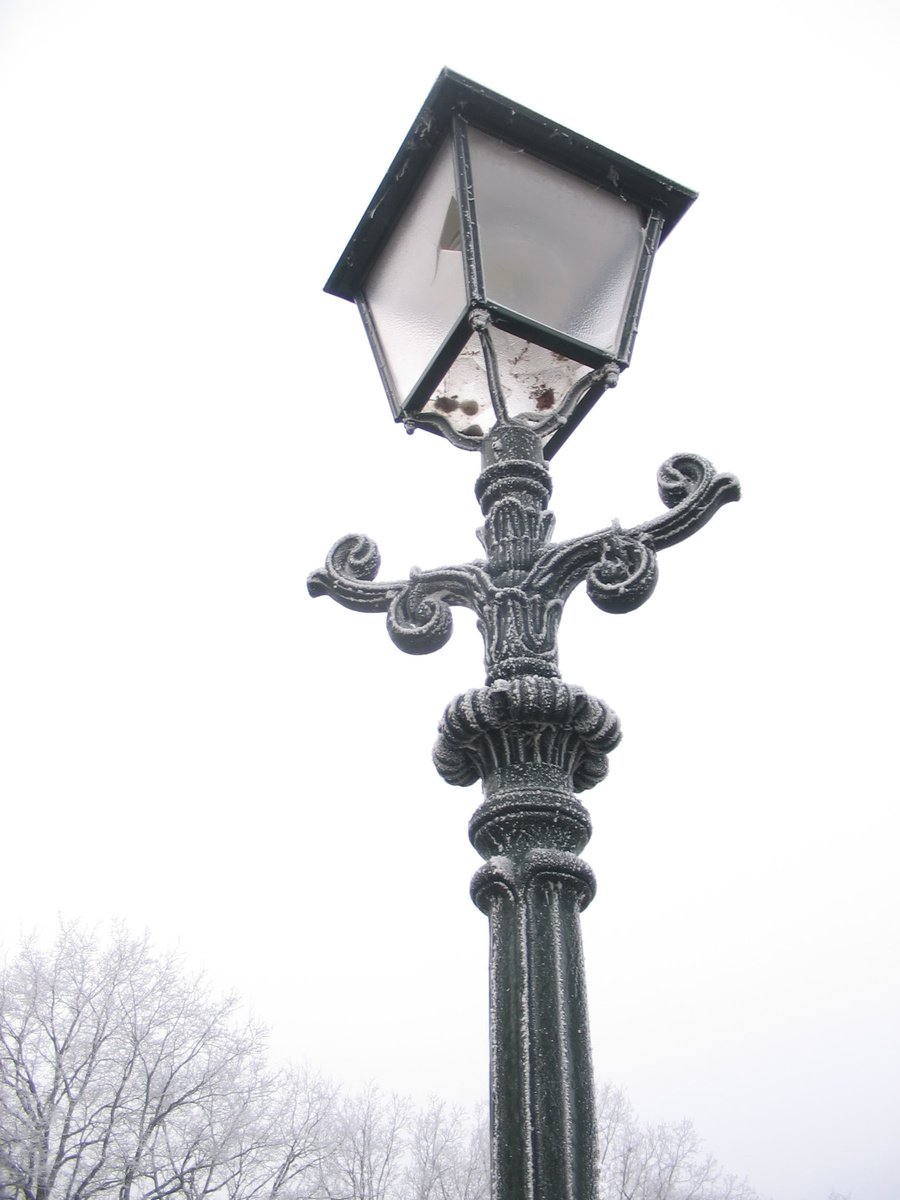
[{"xmin": 0, "ymin": 0, "xmax": 900, "ymax": 1200}]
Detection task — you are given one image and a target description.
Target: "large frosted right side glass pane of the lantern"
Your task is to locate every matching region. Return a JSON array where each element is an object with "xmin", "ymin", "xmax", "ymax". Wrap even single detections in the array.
[{"xmin": 469, "ymin": 127, "xmax": 646, "ymax": 354}]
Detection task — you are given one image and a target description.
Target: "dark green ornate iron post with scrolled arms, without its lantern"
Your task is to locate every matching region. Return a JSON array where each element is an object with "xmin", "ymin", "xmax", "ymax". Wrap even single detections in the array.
[{"xmin": 308, "ymin": 414, "xmax": 739, "ymax": 1200}]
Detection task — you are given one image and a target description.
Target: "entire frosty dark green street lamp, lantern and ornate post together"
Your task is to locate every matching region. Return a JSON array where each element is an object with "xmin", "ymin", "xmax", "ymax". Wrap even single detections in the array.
[{"xmin": 308, "ymin": 71, "xmax": 739, "ymax": 1200}]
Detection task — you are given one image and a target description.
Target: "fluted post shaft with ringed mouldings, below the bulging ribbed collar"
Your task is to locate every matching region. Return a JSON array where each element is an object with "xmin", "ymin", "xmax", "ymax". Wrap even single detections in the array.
[{"xmin": 470, "ymin": 763, "xmax": 595, "ymax": 1200}]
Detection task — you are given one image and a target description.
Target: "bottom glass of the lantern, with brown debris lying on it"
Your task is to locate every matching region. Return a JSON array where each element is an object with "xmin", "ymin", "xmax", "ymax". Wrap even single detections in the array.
[{"xmin": 422, "ymin": 326, "xmax": 592, "ymax": 437}]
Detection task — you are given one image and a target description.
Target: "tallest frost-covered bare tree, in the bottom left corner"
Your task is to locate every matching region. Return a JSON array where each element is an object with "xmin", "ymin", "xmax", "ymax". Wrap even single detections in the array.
[{"xmin": 0, "ymin": 926, "xmax": 331, "ymax": 1200}]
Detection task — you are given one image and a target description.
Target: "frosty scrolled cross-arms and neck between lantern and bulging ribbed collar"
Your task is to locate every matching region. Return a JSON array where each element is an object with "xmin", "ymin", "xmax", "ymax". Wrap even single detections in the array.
[{"xmin": 308, "ymin": 446, "xmax": 740, "ymax": 684}]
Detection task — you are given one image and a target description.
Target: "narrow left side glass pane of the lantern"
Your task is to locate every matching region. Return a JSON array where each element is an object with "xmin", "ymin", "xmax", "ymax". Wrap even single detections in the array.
[{"xmin": 365, "ymin": 140, "xmax": 466, "ymax": 404}]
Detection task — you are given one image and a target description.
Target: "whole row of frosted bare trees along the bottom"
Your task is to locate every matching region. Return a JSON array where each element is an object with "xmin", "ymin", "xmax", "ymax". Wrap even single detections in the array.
[{"xmin": 0, "ymin": 928, "xmax": 756, "ymax": 1200}]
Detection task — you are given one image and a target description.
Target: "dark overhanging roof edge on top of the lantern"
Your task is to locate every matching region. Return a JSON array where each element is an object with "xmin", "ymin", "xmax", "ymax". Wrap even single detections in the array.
[{"xmin": 325, "ymin": 67, "xmax": 697, "ymax": 300}]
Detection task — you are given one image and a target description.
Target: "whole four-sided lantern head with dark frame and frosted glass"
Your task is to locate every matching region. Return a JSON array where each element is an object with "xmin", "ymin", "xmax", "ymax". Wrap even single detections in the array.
[{"xmin": 325, "ymin": 70, "xmax": 695, "ymax": 457}]
